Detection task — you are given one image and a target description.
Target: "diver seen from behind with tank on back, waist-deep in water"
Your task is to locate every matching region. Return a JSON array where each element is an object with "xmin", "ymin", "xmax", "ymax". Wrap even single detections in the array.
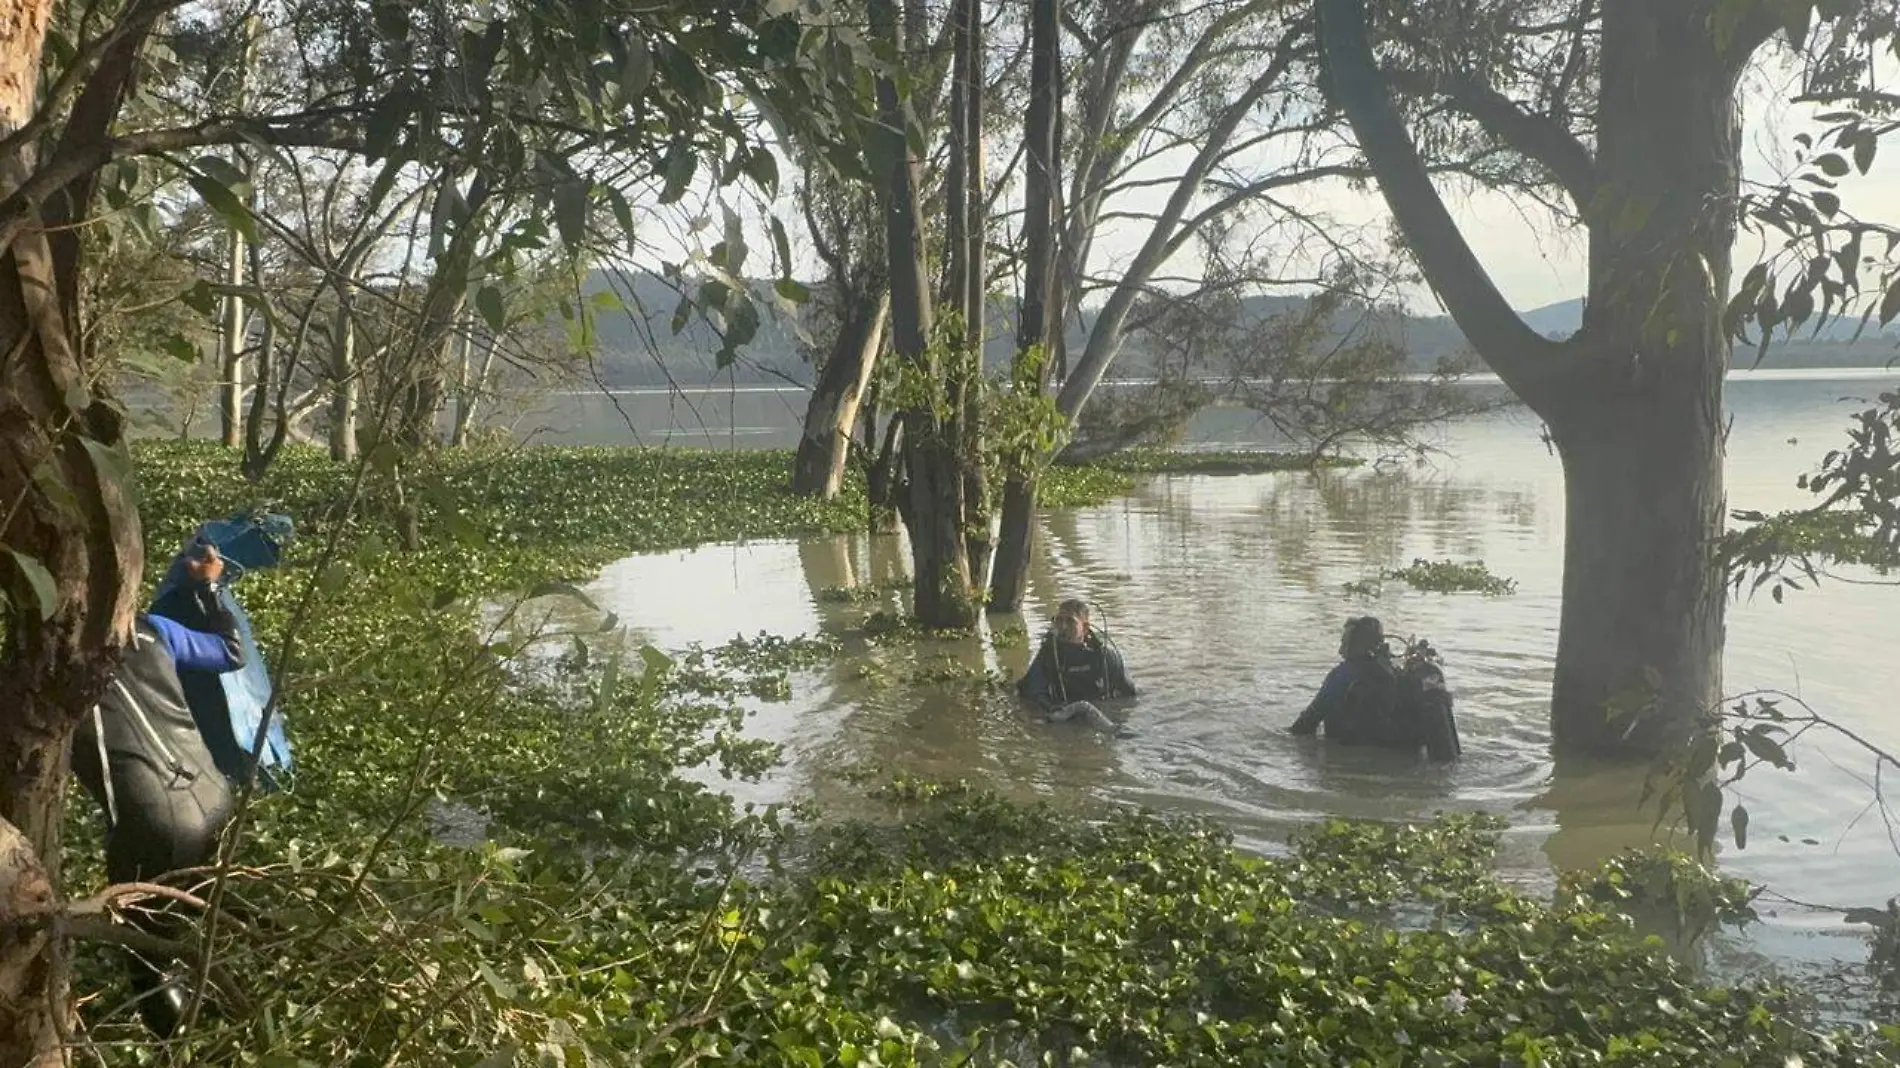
[{"xmin": 1290, "ymin": 616, "xmax": 1463, "ymax": 762}]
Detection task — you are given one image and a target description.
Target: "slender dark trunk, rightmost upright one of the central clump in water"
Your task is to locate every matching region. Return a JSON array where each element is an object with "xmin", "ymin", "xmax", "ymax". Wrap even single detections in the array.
[{"xmin": 988, "ymin": 0, "xmax": 1062, "ymax": 612}]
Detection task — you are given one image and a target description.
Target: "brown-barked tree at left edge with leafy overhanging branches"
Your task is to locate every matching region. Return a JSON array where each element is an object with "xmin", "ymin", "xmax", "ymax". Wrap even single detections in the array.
[{"xmin": 0, "ymin": 0, "xmax": 865, "ymax": 1066}]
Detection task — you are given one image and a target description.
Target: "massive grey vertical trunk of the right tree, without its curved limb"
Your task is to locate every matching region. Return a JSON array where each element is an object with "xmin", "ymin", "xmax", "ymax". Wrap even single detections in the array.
[{"xmin": 1549, "ymin": 0, "xmax": 1742, "ymax": 751}]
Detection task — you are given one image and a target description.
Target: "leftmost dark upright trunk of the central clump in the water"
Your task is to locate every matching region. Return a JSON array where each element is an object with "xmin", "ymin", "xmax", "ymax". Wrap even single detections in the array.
[{"xmin": 870, "ymin": 0, "xmax": 977, "ymax": 627}]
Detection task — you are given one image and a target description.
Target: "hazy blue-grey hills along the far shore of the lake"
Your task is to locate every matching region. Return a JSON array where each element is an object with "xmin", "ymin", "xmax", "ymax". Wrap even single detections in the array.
[{"xmin": 554, "ymin": 272, "xmax": 1900, "ymax": 388}]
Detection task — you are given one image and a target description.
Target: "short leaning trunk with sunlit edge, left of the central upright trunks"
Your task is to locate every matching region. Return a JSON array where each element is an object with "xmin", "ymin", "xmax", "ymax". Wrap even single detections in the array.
[{"xmin": 792, "ymin": 289, "xmax": 891, "ymax": 500}]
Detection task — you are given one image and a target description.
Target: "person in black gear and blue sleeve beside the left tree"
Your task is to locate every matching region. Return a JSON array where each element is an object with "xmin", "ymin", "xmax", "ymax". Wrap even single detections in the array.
[{"xmin": 72, "ymin": 545, "xmax": 243, "ymax": 1036}]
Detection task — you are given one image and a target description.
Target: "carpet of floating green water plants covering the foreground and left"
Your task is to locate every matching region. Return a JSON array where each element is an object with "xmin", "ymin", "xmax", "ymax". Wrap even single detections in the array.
[{"xmin": 77, "ymin": 437, "xmax": 1900, "ymax": 1068}]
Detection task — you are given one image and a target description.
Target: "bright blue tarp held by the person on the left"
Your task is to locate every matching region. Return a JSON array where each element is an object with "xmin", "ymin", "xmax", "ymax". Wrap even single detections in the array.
[{"xmin": 152, "ymin": 513, "xmax": 295, "ymax": 789}]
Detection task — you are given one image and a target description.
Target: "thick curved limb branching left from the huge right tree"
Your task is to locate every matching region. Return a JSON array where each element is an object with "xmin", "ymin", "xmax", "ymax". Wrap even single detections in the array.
[{"xmin": 1317, "ymin": 0, "xmax": 1564, "ymax": 409}]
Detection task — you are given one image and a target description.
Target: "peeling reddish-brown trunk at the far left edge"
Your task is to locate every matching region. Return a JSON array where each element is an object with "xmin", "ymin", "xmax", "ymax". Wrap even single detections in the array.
[{"xmin": 0, "ymin": 16, "xmax": 144, "ymax": 1068}]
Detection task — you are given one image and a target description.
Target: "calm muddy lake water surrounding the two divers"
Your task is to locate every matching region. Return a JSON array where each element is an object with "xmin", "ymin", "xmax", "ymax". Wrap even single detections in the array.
[{"xmin": 519, "ymin": 364, "xmax": 1900, "ymax": 995}]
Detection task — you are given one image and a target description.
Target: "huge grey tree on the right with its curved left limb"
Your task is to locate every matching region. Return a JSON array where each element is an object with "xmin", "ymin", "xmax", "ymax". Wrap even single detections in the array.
[{"xmin": 1317, "ymin": 0, "xmax": 1884, "ymax": 751}]
